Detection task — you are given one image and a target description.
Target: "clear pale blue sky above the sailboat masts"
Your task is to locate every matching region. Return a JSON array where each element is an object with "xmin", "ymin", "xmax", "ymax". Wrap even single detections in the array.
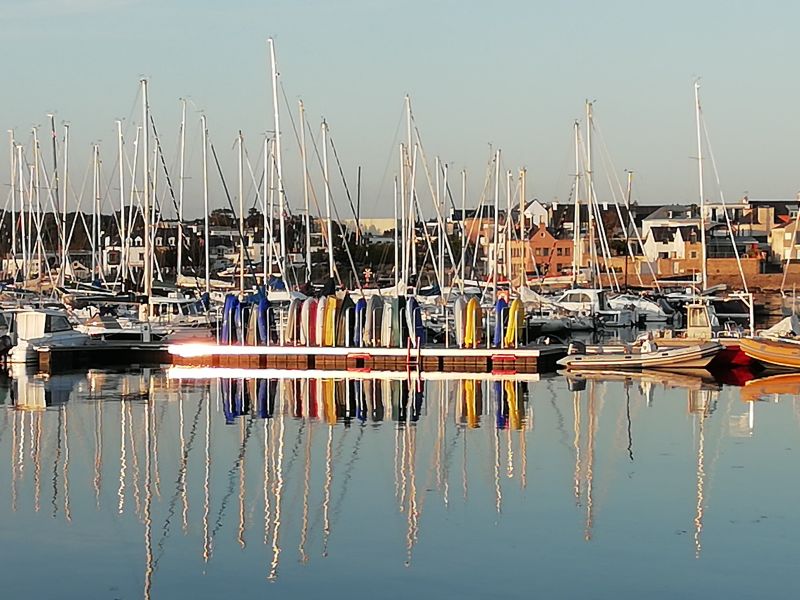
[{"xmin": 0, "ymin": 0, "xmax": 800, "ymax": 216}]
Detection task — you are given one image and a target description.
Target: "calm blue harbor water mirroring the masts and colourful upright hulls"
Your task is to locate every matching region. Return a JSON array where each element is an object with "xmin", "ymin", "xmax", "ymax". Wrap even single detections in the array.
[{"xmin": 0, "ymin": 370, "xmax": 800, "ymax": 598}]
